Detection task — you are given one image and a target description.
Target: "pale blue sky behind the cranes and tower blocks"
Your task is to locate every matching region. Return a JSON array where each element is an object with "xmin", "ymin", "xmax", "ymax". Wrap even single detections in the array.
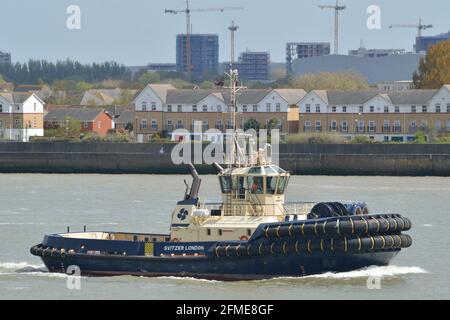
[{"xmin": 0, "ymin": 0, "xmax": 450, "ymax": 66}]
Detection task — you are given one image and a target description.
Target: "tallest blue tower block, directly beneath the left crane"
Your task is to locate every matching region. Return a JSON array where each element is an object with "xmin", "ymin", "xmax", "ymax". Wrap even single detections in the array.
[{"xmin": 176, "ymin": 34, "xmax": 219, "ymax": 75}]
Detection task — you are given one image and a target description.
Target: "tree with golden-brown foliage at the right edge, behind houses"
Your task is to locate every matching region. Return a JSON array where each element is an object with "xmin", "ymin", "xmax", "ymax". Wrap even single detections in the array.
[{"xmin": 413, "ymin": 40, "xmax": 450, "ymax": 89}]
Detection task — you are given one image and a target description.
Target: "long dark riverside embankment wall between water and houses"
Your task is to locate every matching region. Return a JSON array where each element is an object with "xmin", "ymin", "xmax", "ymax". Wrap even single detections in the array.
[{"xmin": 0, "ymin": 142, "xmax": 450, "ymax": 176}]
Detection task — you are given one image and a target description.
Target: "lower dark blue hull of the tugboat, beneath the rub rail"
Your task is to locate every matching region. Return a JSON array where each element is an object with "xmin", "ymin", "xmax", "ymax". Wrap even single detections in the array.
[{"xmin": 37, "ymin": 250, "xmax": 399, "ymax": 280}]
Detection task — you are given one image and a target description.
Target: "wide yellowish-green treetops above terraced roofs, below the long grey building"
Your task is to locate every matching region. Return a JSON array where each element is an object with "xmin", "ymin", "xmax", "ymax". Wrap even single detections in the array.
[{"xmin": 290, "ymin": 72, "xmax": 369, "ymax": 91}]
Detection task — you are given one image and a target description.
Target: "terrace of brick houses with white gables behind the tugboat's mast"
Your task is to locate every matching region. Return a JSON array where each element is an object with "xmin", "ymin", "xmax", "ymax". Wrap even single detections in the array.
[{"xmin": 134, "ymin": 84, "xmax": 306, "ymax": 142}]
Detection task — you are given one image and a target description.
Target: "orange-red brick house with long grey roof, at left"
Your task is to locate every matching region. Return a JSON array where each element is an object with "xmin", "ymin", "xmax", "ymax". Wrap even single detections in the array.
[{"xmin": 44, "ymin": 107, "xmax": 114, "ymax": 136}]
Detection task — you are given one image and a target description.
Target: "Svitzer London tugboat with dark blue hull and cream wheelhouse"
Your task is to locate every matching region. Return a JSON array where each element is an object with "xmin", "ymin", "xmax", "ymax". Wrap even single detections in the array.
[{"xmin": 30, "ymin": 70, "xmax": 412, "ymax": 280}]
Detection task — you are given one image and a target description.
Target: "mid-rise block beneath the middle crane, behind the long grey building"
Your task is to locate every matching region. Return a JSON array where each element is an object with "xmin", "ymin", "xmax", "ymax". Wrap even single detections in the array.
[{"xmin": 286, "ymin": 42, "xmax": 331, "ymax": 74}]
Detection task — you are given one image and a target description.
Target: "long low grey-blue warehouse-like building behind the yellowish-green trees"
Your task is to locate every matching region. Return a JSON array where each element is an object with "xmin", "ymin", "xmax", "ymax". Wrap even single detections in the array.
[{"xmin": 292, "ymin": 53, "xmax": 422, "ymax": 83}]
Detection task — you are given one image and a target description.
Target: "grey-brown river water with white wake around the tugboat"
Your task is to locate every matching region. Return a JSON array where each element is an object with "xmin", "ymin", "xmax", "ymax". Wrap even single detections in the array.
[{"xmin": 0, "ymin": 174, "xmax": 450, "ymax": 299}]
